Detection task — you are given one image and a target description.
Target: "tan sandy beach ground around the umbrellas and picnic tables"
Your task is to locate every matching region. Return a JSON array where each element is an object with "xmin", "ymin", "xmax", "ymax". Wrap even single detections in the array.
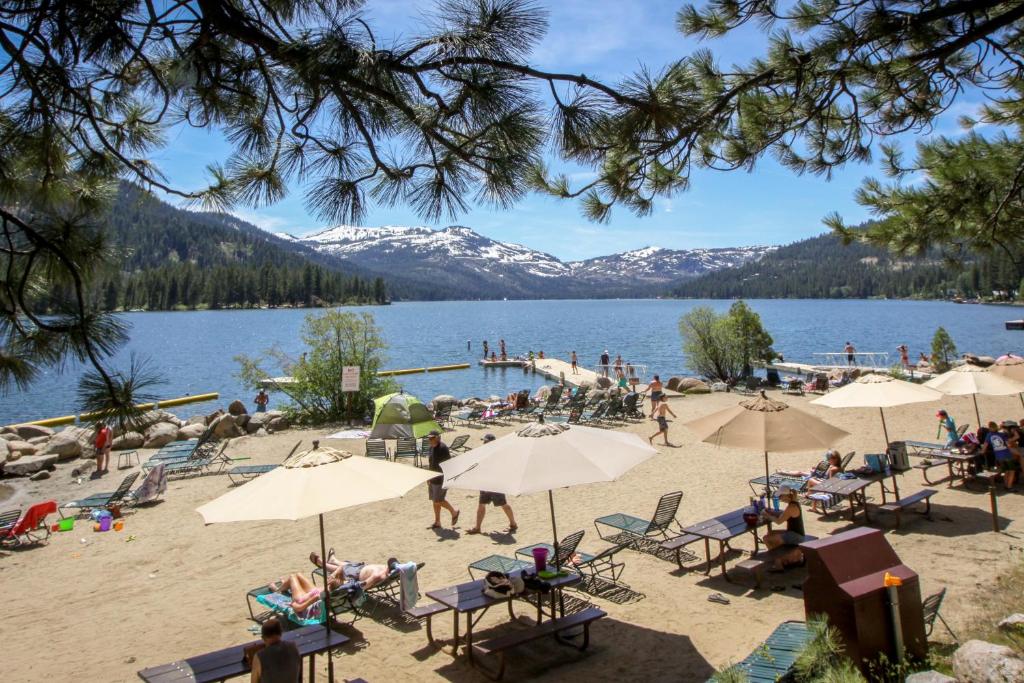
[{"xmin": 0, "ymin": 394, "xmax": 1024, "ymax": 682}]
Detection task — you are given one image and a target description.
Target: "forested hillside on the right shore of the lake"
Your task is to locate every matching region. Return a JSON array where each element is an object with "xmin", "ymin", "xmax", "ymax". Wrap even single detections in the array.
[{"xmin": 671, "ymin": 234, "xmax": 1020, "ymax": 299}]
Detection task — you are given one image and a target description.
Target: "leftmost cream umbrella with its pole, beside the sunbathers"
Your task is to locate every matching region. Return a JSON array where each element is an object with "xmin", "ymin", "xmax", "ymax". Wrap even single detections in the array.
[{"xmin": 196, "ymin": 441, "xmax": 435, "ymax": 681}]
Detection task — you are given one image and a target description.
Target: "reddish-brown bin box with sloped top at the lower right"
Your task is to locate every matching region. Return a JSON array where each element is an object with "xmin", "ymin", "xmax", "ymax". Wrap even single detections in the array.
[{"xmin": 800, "ymin": 528, "xmax": 928, "ymax": 675}]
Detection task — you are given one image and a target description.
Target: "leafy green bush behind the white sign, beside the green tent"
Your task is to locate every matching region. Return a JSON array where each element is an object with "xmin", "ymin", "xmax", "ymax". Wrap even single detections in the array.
[{"xmin": 234, "ymin": 310, "xmax": 397, "ymax": 423}]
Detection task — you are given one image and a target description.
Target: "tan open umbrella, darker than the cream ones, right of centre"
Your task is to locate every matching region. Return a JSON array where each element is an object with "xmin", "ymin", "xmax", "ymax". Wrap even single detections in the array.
[{"xmin": 686, "ymin": 391, "xmax": 849, "ymax": 493}]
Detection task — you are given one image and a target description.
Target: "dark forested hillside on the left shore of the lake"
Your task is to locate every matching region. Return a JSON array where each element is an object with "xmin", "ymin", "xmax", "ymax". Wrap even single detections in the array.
[{"xmin": 50, "ymin": 184, "xmax": 388, "ymax": 310}]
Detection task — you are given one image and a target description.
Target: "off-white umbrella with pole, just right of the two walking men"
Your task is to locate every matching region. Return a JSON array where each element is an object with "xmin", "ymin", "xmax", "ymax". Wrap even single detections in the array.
[{"xmin": 441, "ymin": 423, "xmax": 657, "ymax": 562}]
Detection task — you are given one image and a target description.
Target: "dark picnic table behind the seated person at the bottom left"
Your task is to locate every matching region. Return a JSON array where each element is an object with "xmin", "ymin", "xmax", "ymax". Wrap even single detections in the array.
[{"xmin": 138, "ymin": 626, "xmax": 348, "ymax": 683}]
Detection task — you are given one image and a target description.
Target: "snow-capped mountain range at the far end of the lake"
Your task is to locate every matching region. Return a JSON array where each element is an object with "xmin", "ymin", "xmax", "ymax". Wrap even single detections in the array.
[{"xmin": 278, "ymin": 225, "xmax": 774, "ymax": 299}]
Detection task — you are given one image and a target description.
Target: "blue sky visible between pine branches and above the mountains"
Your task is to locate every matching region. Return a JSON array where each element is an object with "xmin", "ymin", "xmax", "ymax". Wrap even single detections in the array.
[{"xmin": 154, "ymin": 0, "xmax": 969, "ymax": 260}]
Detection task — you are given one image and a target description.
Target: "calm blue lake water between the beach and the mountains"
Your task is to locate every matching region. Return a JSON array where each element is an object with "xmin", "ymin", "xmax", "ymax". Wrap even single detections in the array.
[{"xmin": 0, "ymin": 300, "xmax": 1024, "ymax": 424}]
